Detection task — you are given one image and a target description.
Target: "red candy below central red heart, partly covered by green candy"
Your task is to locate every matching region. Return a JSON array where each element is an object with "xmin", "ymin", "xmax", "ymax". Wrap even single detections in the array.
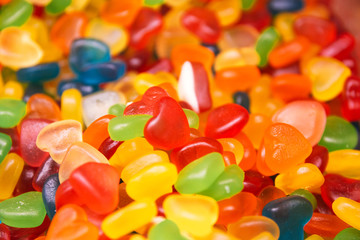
[{"xmin": 170, "ymin": 137, "xmax": 223, "ymax": 172}]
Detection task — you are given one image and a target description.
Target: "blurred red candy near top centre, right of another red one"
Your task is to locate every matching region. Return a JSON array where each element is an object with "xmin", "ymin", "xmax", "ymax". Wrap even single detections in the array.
[{"xmin": 181, "ymin": 8, "xmax": 221, "ymax": 44}]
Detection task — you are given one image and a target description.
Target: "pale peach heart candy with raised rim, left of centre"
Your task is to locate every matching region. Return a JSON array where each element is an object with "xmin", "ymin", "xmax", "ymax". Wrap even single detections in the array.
[{"xmin": 36, "ymin": 120, "xmax": 82, "ymax": 164}]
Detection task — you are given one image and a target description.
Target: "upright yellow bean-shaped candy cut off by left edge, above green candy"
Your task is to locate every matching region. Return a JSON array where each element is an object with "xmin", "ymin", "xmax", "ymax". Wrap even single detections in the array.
[{"xmin": 0, "ymin": 153, "xmax": 25, "ymax": 199}]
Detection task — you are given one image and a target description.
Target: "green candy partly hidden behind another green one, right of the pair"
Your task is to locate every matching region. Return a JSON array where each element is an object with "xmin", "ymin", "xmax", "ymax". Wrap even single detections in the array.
[{"xmin": 199, "ymin": 164, "xmax": 245, "ymax": 201}]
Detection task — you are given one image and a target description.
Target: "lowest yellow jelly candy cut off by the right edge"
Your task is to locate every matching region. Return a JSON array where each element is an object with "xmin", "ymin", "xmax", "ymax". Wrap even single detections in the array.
[{"xmin": 332, "ymin": 197, "xmax": 360, "ymax": 230}]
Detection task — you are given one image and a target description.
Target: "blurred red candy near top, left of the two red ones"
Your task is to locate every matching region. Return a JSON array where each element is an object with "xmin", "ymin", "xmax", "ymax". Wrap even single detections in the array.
[{"xmin": 130, "ymin": 7, "xmax": 163, "ymax": 49}]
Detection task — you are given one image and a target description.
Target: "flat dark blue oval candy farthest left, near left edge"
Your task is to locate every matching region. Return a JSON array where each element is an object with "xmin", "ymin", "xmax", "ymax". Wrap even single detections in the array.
[{"xmin": 16, "ymin": 62, "xmax": 60, "ymax": 82}]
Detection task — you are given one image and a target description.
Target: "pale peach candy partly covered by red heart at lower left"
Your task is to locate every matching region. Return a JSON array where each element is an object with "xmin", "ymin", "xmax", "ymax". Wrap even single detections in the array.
[{"xmin": 59, "ymin": 142, "xmax": 109, "ymax": 183}]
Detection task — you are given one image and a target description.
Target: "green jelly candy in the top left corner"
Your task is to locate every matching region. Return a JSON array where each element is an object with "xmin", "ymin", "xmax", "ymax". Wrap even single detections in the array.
[{"xmin": 0, "ymin": 0, "xmax": 33, "ymax": 30}]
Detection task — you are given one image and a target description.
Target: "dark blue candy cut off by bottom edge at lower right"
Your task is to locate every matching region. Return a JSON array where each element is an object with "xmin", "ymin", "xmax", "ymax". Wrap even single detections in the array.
[{"xmin": 262, "ymin": 196, "xmax": 313, "ymax": 240}]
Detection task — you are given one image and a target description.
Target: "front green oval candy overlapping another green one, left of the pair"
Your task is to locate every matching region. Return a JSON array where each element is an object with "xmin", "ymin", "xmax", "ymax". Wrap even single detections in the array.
[{"xmin": 175, "ymin": 152, "xmax": 225, "ymax": 194}]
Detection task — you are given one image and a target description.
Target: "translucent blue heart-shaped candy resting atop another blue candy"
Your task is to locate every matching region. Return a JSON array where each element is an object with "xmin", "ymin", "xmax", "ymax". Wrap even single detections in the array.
[{"xmin": 69, "ymin": 38, "xmax": 111, "ymax": 73}]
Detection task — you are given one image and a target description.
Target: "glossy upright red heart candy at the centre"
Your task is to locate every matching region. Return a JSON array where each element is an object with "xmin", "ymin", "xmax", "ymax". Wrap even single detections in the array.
[{"xmin": 144, "ymin": 97, "xmax": 190, "ymax": 150}]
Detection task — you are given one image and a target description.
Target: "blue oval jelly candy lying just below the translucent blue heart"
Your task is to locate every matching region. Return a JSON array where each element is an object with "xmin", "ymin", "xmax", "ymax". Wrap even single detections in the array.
[{"xmin": 79, "ymin": 61, "xmax": 126, "ymax": 85}]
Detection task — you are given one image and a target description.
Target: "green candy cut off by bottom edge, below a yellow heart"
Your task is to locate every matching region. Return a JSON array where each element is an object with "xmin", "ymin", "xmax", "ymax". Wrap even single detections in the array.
[{"xmin": 148, "ymin": 220, "xmax": 187, "ymax": 240}]
